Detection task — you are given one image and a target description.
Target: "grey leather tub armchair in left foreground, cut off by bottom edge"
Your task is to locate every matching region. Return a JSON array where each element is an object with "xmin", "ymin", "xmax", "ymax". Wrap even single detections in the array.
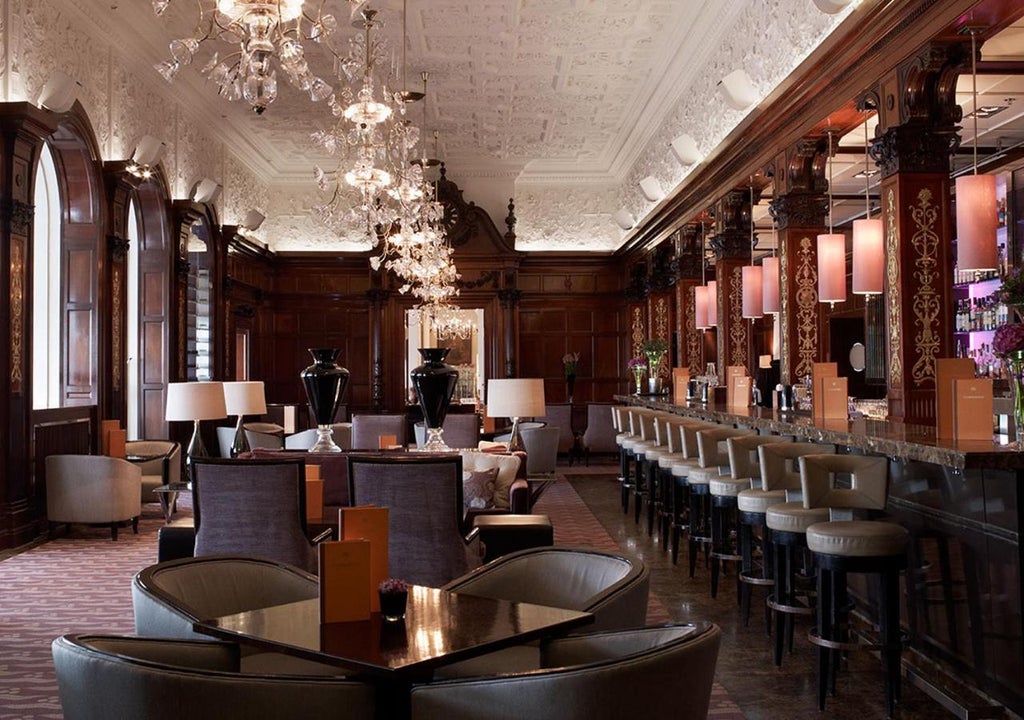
[{"xmin": 52, "ymin": 635, "xmax": 376, "ymax": 720}]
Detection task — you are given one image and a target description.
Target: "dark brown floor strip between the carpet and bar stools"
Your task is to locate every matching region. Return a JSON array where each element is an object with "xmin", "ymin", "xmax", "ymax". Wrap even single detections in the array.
[{"xmin": 567, "ymin": 461, "xmax": 983, "ymax": 720}]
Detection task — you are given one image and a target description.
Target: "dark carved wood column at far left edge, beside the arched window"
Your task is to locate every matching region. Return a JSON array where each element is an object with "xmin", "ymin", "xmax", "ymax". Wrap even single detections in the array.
[{"xmin": 0, "ymin": 102, "xmax": 57, "ymax": 549}]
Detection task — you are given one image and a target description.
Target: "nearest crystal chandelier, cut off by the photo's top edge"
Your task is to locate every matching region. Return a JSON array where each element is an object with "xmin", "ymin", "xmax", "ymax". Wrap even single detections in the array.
[{"xmin": 153, "ymin": 0, "xmax": 338, "ymax": 115}]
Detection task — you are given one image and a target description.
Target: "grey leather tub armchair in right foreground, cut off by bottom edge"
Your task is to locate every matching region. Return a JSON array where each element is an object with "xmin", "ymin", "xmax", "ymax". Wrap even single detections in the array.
[{"xmin": 412, "ymin": 623, "xmax": 721, "ymax": 720}]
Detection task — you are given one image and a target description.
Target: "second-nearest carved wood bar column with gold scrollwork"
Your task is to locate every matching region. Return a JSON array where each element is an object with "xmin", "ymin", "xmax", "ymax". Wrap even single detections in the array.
[{"xmin": 771, "ymin": 138, "xmax": 828, "ymax": 384}]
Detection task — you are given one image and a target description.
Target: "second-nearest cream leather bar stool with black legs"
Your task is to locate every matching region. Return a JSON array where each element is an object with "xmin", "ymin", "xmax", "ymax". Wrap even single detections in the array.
[{"xmin": 758, "ymin": 442, "xmax": 836, "ymax": 667}]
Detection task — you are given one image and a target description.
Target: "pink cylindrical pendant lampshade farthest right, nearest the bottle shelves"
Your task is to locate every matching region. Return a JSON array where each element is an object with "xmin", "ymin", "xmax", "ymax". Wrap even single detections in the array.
[{"xmin": 956, "ymin": 175, "xmax": 998, "ymax": 270}]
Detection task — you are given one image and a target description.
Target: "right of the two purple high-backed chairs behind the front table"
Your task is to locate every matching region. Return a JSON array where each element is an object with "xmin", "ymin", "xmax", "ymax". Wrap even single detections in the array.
[{"xmin": 348, "ymin": 454, "xmax": 480, "ymax": 587}]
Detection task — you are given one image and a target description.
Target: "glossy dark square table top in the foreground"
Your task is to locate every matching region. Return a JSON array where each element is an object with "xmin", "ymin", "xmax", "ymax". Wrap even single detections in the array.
[{"xmin": 196, "ymin": 585, "xmax": 594, "ymax": 680}]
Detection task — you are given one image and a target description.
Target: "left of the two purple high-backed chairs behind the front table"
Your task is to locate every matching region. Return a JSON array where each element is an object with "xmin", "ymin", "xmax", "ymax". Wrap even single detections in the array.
[{"xmin": 193, "ymin": 458, "xmax": 316, "ymax": 573}]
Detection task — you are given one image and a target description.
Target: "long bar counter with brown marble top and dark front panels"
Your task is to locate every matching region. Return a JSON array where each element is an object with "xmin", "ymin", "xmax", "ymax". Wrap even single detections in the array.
[{"xmin": 616, "ymin": 395, "xmax": 1024, "ymax": 715}]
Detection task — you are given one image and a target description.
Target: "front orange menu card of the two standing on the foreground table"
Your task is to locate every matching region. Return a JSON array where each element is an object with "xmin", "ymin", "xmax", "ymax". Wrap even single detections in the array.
[{"xmin": 317, "ymin": 540, "xmax": 376, "ymax": 623}]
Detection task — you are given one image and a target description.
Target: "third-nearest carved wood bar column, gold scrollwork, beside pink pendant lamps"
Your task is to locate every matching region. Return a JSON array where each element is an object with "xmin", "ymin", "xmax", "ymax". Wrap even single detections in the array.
[{"xmin": 711, "ymin": 187, "xmax": 755, "ymax": 383}]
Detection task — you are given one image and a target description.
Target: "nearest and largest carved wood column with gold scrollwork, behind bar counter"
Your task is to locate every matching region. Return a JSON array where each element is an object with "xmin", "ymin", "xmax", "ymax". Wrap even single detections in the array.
[{"xmin": 871, "ymin": 43, "xmax": 970, "ymax": 424}]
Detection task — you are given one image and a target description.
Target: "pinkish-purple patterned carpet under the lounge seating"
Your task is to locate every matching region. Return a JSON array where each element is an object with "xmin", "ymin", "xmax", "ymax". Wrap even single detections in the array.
[{"xmin": 0, "ymin": 475, "xmax": 743, "ymax": 720}]
